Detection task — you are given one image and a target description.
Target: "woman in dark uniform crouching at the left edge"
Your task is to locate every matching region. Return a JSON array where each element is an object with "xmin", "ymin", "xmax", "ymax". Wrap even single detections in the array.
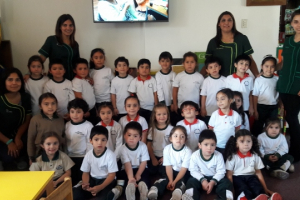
[{"xmin": 0, "ymin": 68, "xmax": 31, "ymax": 167}]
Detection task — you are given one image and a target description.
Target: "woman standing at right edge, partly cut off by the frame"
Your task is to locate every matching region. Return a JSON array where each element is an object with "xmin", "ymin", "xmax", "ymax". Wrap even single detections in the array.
[{"xmin": 277, "ymin": 10, "xmax": 300, "ymax": 162}]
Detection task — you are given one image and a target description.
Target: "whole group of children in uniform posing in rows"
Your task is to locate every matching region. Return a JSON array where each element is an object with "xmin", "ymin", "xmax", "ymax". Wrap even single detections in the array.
[{"xmin": 9, "ymin": 49, "xmax": 294, "ymax": 200}]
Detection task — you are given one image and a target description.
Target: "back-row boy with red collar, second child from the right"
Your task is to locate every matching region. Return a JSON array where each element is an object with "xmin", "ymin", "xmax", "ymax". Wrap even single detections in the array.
[{"xmin": 226, "ymin": 54, "xmax": 254, "ymax": 116}]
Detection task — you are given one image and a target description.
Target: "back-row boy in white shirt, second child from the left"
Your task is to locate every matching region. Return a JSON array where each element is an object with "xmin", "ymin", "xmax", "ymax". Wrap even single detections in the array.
[{"xmin": 43, "ymin": 59, "xmax": 75, "ymax": 118}]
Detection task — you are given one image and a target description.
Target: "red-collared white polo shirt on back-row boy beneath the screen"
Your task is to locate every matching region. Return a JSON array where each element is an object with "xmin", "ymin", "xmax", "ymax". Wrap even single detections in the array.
[{"xmin": 128, "ymin": 75, "xmax": 157, "ymax": 111}]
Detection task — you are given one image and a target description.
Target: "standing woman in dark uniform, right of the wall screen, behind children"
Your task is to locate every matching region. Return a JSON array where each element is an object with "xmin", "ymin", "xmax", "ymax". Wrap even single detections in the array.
[{"xmin": 201, "ymin": 11, "xmax": 259, "ymax": 76}]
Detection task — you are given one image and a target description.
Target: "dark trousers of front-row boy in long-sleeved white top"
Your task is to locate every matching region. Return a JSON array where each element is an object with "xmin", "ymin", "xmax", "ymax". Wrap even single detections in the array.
[{"xmin": 186, "ymin": 176, "xmax": 232, "ymax": 200}]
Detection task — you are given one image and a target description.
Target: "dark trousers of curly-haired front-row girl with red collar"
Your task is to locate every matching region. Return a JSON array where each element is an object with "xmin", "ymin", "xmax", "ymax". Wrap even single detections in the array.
[{"xmin": 232, "ymin": 175, "xmax": 265, "ymax": 199}]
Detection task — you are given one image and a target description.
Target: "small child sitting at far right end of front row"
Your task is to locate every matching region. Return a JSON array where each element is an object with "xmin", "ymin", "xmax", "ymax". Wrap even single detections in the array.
[{"xmin": 257, "ymin": 118, "xmax": 295, "ymax": 179}]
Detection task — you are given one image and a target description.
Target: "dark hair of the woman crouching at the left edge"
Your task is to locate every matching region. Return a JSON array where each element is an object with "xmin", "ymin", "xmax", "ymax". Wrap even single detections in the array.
[{"xmin": 0, "ymin": 67, "xmax": 25, "ymax": 95}]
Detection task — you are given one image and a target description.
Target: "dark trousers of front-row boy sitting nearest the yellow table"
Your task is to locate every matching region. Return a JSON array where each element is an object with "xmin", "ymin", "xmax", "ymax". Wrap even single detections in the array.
[{"xmin": 73, "ymin": 177, "xmax": 117, "ymax": 200}]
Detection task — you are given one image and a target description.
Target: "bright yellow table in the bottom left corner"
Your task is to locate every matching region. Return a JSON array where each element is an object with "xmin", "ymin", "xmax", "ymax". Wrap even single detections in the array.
[{"xmin": 0, "ymin": 171, "xmax": 54, "ymax": 200}]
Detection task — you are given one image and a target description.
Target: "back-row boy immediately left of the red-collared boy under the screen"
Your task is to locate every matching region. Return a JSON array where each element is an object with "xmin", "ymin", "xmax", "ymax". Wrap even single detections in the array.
[{"xmin": 110, "ymin": 57, "xmax": 133, "ymax": 121}]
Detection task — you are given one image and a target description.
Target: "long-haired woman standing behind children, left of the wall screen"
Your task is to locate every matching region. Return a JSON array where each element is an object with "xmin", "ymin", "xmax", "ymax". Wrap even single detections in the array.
[{"xmin": 39, "ymin": 14, "xmax": 79, "ymax": 80}]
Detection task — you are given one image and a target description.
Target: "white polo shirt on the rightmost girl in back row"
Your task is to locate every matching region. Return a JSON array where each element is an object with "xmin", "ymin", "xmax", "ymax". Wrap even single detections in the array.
[{"xmin": 252, "ymin": 75, "xmax": 279, "ymax": 105}]
